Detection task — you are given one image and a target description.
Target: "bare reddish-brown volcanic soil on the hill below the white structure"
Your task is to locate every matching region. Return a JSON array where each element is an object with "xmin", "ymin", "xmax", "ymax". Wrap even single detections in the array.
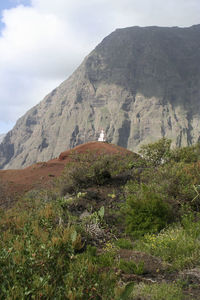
[{"xmin": 0, "ymin": 142, "xmax": 131, "ymax": 200}]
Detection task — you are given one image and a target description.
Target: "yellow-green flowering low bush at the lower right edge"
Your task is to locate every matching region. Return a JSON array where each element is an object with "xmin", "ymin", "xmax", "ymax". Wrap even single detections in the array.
[{"xmin": 136, "ymin": 214, "xmax": 200, "ymax": 269}]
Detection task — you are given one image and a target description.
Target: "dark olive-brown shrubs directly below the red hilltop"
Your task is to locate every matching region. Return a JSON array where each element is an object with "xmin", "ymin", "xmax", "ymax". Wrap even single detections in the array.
[{"xmin": 59, "ymin": 151, "xmax": 144, "ymax": 196}]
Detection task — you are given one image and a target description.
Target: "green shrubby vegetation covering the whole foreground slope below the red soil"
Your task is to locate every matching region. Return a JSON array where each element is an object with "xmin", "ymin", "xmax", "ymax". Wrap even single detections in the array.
[{"xmin": 0, "ymin": 139, "xmax": 200, "ymax": 300}]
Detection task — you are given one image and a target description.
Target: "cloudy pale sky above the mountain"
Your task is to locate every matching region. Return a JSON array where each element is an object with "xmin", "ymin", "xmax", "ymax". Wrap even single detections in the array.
[{"xmin": 0, "ymin": 0, "xmax": 200, "ymax": 134}]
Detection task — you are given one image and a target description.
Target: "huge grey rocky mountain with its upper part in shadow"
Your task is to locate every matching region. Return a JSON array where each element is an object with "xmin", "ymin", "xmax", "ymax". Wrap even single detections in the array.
[{"xmin": 0, "ymin": 25, "xmax": 200, "ymax": 168}]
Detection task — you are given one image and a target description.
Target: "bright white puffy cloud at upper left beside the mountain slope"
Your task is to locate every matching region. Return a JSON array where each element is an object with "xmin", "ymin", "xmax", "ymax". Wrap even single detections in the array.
[{"xmin": 0, "ymin": 6, "xmax": 90, "ymax": 78}]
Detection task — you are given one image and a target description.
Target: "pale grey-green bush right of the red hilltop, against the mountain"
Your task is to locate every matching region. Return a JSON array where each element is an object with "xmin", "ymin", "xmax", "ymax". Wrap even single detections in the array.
[{"xmin": 140, "ymin": 138, "xmax": 171, "ymax": 166}]
